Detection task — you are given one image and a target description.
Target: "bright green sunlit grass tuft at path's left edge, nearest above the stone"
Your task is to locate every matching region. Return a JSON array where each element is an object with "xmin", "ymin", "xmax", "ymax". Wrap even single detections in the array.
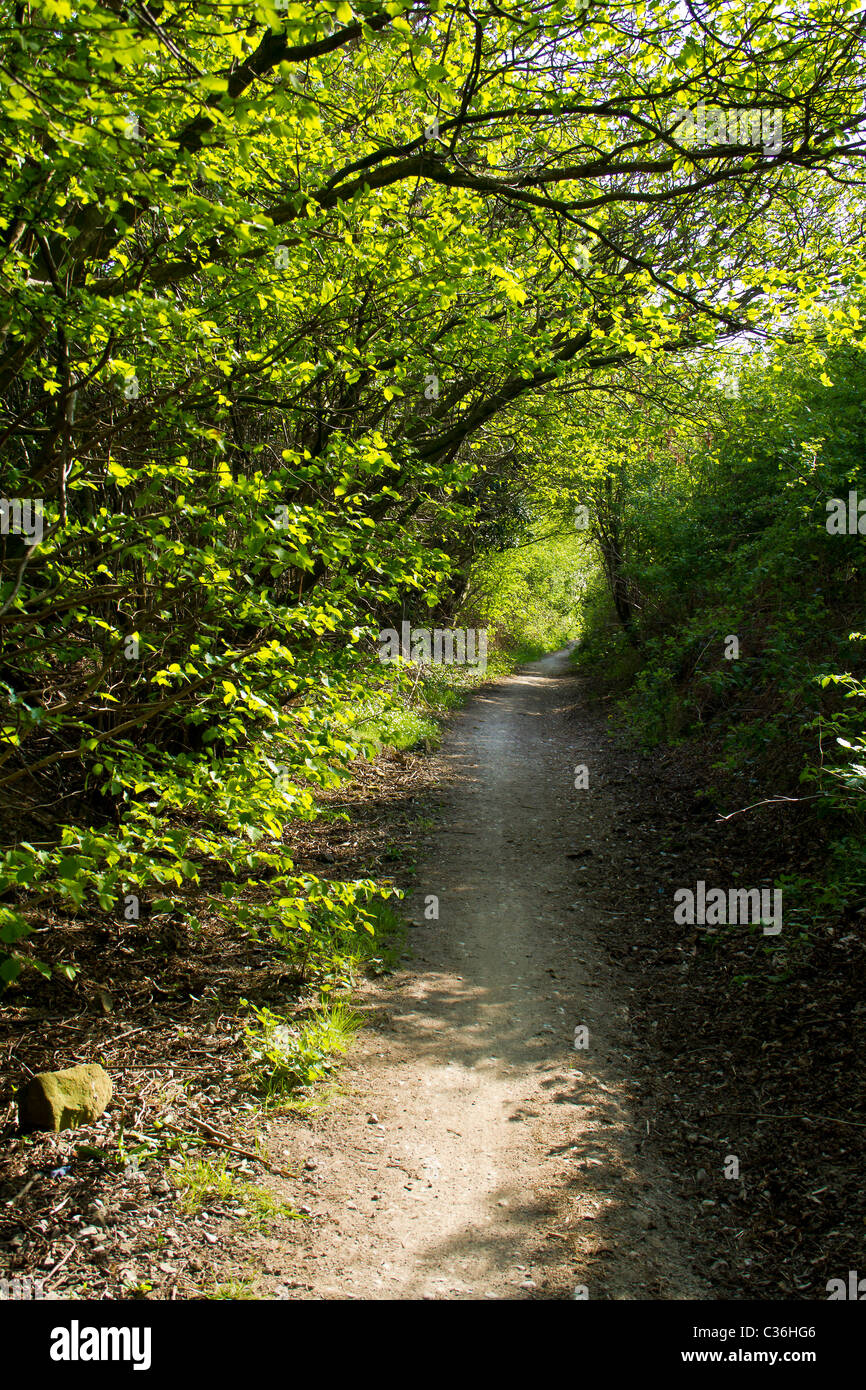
[{"xmin": 242, "ymin": 1001, "xmax": 363, "ymax": 1105}]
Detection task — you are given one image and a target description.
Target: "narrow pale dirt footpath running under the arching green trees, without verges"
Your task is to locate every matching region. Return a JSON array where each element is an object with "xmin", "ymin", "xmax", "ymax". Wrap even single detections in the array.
[{"xmin": 260, "ymin": 652, "xmax": 713, "ymax": 1300}]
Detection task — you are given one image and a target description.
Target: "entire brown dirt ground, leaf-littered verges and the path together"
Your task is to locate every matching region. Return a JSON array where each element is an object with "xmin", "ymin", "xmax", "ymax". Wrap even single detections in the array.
[{"xmin": 0, "ymin": 651, "xmax": 866, "ymax": 1301}]
